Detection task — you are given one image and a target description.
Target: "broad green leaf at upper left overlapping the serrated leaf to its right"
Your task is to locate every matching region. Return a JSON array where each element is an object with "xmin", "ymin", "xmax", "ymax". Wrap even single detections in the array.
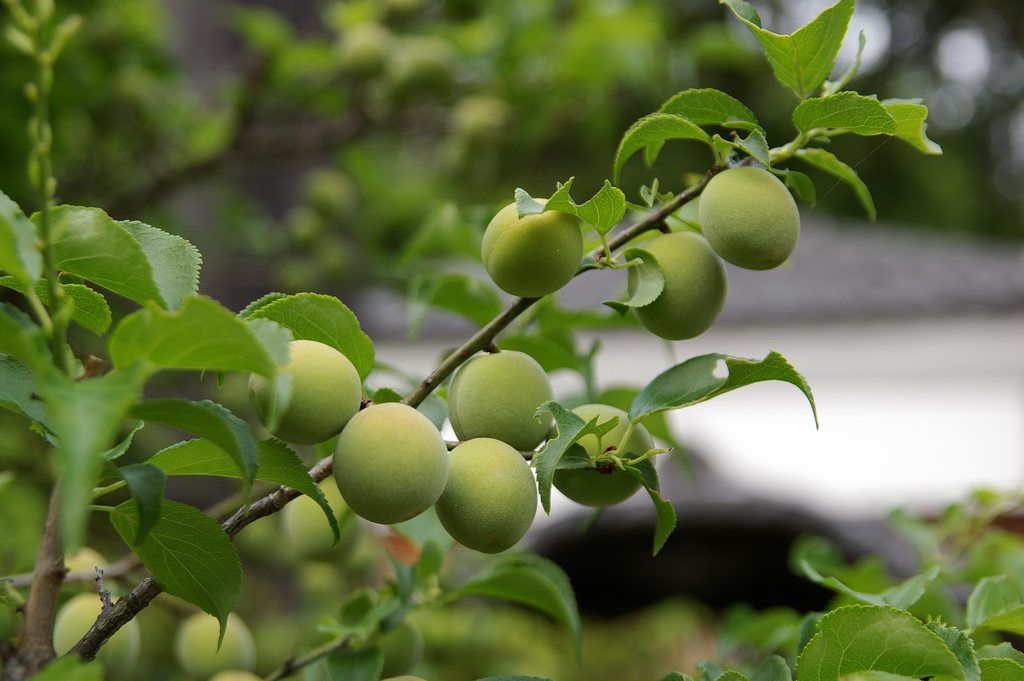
[{"xmin": 47, "ymin": 206, "xmax": 166, "ymax": 306}]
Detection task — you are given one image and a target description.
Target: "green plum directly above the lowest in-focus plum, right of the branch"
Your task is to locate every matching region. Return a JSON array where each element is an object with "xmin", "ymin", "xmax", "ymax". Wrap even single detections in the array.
[{"xmin": 449, "ymin": 350, "xmax": 554, "ymax": 451}]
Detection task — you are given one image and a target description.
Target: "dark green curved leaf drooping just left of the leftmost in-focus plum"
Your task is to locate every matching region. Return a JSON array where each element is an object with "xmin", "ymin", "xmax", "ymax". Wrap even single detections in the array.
[{"xmin": 131, "ymin": 398, "xmax": 260, "ymax": 486}]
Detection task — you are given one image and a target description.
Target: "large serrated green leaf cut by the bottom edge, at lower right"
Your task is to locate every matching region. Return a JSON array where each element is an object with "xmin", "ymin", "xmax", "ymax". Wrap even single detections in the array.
[{"xmin": 797, "ymin": 605, "xmax": 964, "ymax": 681}]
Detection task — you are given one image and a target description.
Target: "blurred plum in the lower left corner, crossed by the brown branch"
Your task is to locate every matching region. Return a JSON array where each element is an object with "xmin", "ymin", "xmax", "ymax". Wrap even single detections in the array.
[{"xmin": 53, "ymin": 593, "xmax": 141, "ymax": 679}]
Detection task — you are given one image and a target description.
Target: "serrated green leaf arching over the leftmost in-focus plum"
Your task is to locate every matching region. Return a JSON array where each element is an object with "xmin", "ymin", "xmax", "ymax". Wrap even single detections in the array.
[{"xmin": 249, "ymin": 293, "xmax": 374, "ymax": 378}]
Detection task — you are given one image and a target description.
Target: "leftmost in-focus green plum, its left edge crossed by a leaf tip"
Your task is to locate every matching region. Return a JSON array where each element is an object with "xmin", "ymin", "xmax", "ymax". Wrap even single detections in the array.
[{"xmin": 249, "ymin": 340, "xmax": 362, "ymax": 444}]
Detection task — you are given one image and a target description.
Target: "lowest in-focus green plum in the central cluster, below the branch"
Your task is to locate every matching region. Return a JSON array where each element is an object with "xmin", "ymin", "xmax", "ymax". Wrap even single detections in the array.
[{"xmin": 436, "ymin": 437, "xmax": 537, "ymax": 553}]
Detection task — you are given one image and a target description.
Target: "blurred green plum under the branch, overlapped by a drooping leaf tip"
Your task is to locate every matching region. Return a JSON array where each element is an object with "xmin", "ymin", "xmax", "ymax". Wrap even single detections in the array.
[{"xmin": 281, "ymin": 478, "xmax": 359, "ymax": 562}]
